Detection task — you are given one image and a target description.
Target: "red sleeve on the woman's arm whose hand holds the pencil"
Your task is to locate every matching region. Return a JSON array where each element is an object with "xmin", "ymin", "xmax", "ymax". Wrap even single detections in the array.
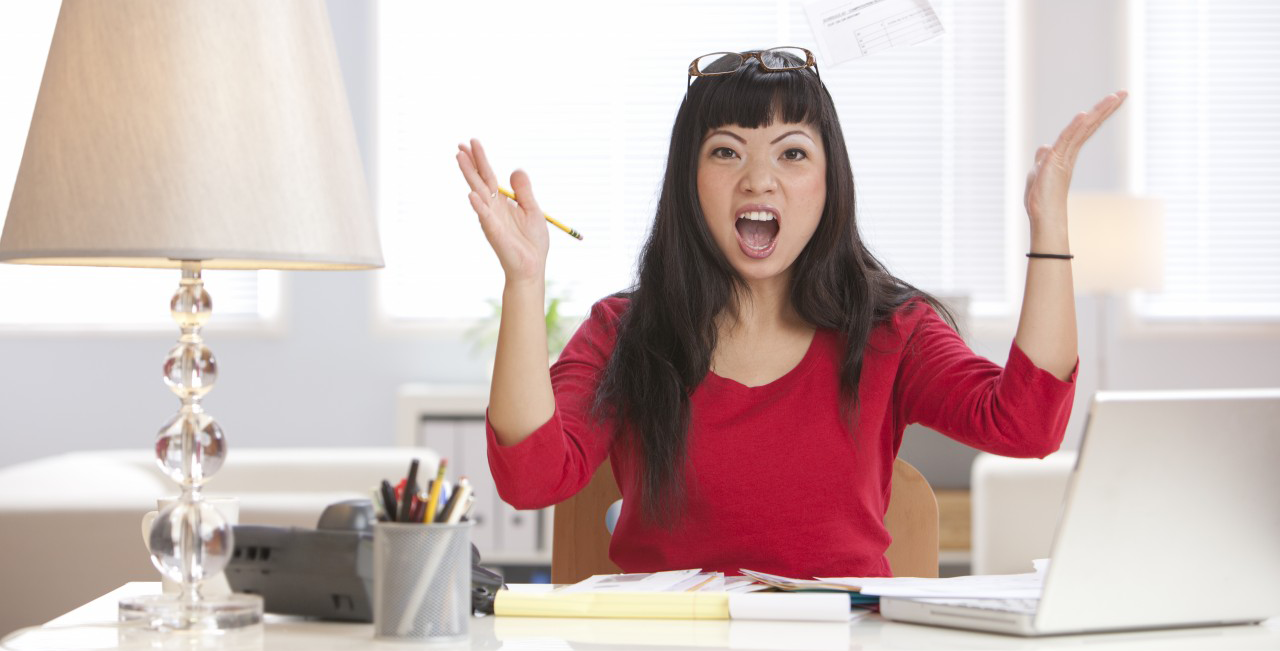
[{"xmin": 485, "ymin": 298, "xmax": 626, "ymax": 509}]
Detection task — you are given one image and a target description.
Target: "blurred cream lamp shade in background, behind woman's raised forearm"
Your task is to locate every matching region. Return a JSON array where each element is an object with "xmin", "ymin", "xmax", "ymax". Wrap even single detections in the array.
[{"xmin": 1068, "ymin": 193, "xmax": 1165, "ymax": 294}]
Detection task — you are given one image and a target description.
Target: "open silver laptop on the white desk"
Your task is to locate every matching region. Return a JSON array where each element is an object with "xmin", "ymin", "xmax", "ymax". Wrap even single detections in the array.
[{"xmin": 881, "ymin": 389, "xmax": 1280, "ymax": 636}]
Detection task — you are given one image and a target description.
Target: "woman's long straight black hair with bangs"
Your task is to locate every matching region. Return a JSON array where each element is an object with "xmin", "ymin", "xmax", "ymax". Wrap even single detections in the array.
[{"xmin": 595, "ymin": 52, "xmax": 954, "ymax": 526}]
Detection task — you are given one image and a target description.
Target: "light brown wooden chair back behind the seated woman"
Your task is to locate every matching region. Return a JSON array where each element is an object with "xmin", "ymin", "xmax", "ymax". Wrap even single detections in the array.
[{"xmin": 552, "ymin": 459, "xmax": 938, "ymax": 583}]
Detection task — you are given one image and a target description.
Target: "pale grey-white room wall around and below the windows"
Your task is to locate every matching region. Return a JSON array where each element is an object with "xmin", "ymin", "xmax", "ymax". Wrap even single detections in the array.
[{"xmin": 0, "ymin": 0, "xmax": 1280, "ymax": 473}]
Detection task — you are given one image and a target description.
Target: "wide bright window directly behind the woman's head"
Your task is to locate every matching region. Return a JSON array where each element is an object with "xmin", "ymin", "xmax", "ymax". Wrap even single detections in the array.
[{"xmin": 378, "ymin": 0, "xmax": 1020, "ymax": 322}]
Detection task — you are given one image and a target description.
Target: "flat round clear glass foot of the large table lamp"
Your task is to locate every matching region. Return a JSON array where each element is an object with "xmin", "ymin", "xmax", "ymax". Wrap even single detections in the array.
[{"xmin": 120, "ymin": 593, "xmax": 262, "ymax": 633}]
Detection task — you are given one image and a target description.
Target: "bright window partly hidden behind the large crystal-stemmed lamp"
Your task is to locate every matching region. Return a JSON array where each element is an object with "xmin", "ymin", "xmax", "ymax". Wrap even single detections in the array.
[{"xmin": 0, "ymin": 0, "xmax": 279, "ymax": 324}]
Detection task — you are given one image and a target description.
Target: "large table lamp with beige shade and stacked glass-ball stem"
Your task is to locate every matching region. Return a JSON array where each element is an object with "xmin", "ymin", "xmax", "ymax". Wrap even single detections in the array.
[{"xmin": 0, "ymin": 0, "xmax": 383, "ymax": 632}]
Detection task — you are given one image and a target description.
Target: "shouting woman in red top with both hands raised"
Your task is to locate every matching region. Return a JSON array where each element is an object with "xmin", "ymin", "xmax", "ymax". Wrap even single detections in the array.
[{"xmin": 458, "ymin": 50, "xmax": 1124, "ymax": 577}]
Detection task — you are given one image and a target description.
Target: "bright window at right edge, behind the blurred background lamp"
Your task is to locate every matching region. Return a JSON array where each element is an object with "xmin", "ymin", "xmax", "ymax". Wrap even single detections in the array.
[{"xmin": 1130, "ymin": 0, "xmax": 1280, "ymax": 320}]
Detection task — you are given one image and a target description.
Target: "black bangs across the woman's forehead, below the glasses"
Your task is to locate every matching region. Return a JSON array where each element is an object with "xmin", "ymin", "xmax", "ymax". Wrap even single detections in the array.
[{"xmin": 690, "ymin": 61, "xmax": 824, "ymax": 133}]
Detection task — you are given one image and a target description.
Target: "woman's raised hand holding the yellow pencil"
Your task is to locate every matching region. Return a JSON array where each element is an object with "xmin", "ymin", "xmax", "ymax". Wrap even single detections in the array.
[{"xmin": 457, "ymin": 138, "xmax": 550, "ymax": 286}]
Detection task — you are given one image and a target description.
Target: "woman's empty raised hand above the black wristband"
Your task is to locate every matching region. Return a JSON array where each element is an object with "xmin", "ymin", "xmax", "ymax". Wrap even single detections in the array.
[{"xmin": 1023, "ymin": 91, "xmax": 1129, "ymax": 228}]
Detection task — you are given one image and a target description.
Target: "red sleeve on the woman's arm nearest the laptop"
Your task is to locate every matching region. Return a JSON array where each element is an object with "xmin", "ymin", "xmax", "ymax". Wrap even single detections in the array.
[{"xmin": 896, "ymin": 303, "xmax": 1079, "ymax": 457}]
